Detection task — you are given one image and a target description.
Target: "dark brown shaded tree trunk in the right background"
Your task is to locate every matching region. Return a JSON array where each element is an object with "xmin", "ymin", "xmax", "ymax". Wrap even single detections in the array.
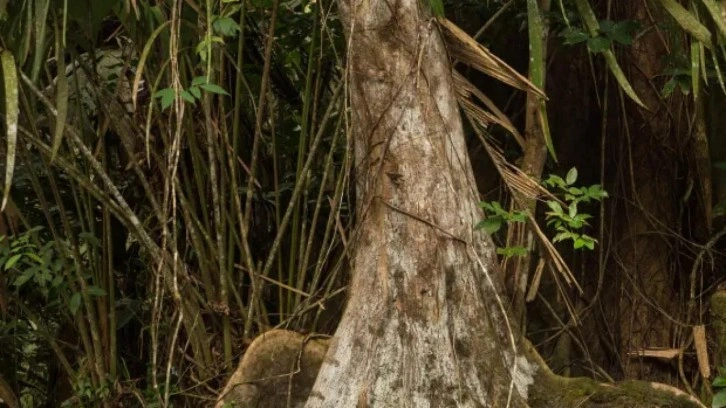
[{"xmin": 612, "ymin": 1, "xmax": 687, "ymax": 382}]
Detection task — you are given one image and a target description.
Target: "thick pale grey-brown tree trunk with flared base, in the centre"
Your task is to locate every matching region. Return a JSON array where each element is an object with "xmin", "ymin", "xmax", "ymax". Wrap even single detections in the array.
[{"xmin": 306, "ymin": 0, "xmax": 536, "ymax": 408}]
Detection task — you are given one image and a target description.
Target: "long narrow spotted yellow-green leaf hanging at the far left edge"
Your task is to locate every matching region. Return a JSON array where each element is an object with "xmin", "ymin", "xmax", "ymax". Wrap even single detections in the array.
[{"xmin": 0, "ymin": 50, "xmax": 20, "ymax": 211}]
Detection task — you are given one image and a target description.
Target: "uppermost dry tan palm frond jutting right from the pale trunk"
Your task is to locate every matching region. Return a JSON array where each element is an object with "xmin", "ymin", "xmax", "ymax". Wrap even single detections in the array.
[{"xmin": 438, "ymin": 18, "xmax": 545, "ymax": 98}]
